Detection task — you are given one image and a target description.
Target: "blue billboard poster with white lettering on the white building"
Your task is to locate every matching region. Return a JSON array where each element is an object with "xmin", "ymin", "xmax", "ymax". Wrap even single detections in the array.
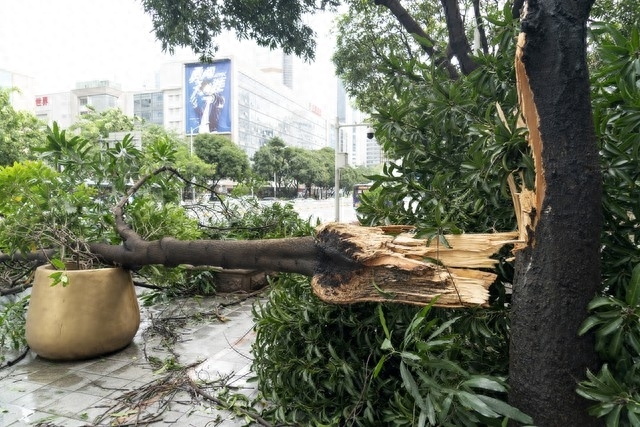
[{"xmin": 184, "ymin": 59, "xmax": 231, "ymax": 134}]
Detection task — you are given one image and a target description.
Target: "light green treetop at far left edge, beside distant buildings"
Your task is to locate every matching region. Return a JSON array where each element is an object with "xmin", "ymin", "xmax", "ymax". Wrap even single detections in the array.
[{"xmin": 0, "ymin": 88, "xmax": 46, "ymax": 166}]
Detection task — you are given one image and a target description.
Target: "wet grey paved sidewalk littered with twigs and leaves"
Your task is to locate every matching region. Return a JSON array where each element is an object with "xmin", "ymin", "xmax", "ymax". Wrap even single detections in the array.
[{"xmin": 0, "ymin": 296, "xmax": 264, "ymax": 427}]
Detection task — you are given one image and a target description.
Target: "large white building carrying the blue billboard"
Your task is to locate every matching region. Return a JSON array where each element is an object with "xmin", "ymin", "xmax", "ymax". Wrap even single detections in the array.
[{"xmin": 151, "ymin": 57, "xmax": 329, "ymax": 157}]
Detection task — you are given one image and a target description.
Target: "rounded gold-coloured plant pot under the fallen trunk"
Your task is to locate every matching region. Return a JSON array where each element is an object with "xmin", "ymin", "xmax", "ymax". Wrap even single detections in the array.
[{"xmin": 26, "ymin": 264, "xmax": 140, "ymax": 360}]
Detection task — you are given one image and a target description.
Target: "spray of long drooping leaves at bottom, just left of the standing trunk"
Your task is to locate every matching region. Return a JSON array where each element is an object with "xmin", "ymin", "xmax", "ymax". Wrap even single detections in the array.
[{"xmin": 374, "ymin": 305, "xmax": 533, "ymax": 426}]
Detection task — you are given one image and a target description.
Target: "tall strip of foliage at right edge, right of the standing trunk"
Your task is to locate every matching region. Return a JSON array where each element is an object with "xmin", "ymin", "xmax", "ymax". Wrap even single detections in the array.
[{"xmin": 591, "ymin": 23, "xmax": 640, "ymax": 297}]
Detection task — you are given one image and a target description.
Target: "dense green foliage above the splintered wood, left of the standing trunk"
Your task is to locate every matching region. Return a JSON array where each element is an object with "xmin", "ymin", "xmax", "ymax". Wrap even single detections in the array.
[{"xmin": 358, "ymin": 9, "xmax": 533, "ymax": 234}]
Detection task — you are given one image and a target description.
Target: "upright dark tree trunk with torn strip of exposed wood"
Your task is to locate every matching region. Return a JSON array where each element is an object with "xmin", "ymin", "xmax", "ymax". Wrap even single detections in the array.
[{"xmin": 509, "ymin": 0, "xmax": 602, "ymax": 427}]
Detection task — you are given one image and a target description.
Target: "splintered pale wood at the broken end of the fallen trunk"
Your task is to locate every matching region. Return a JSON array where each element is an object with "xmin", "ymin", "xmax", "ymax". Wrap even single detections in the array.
[{"xmin": 311, "ymin": 223, "xmax": 518, "ymax": 308}]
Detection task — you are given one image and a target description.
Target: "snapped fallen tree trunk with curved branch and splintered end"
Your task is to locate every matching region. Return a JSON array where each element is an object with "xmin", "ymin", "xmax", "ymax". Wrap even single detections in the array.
[{"xmin": 76, "ymin": 167, "xmax": 517, "ymax": 308}]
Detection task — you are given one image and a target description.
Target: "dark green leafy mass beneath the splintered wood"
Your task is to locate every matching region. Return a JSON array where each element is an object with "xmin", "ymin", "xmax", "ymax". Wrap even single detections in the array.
[{"xmin": 252, "ymin": 275, "xmax": 531, "ymax": 426}]
